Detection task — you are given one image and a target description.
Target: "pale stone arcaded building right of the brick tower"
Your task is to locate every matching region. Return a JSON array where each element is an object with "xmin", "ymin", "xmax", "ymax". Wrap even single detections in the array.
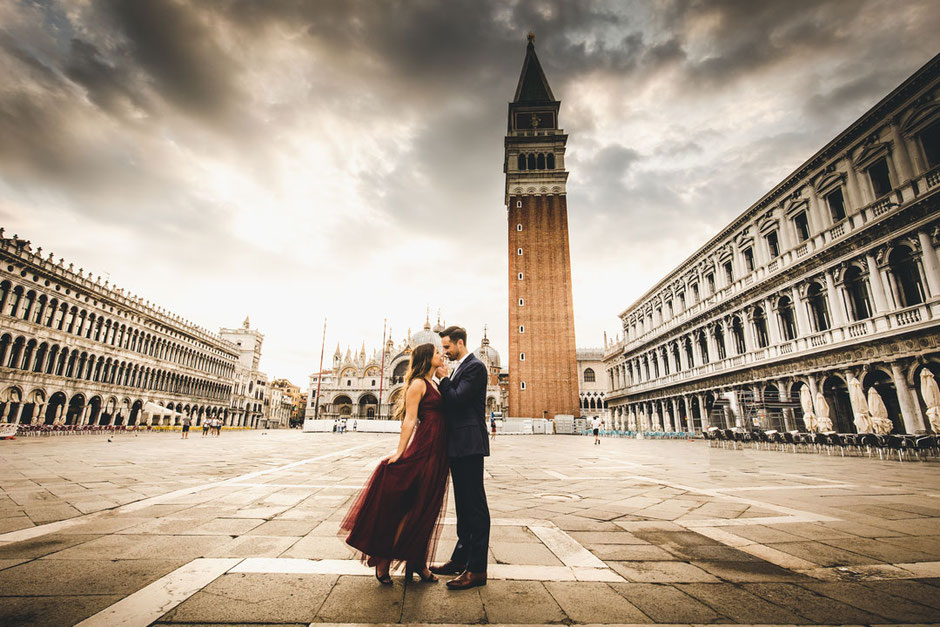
[{"xmin": 604, "ymin": 57, "xmax": 940, "ymax": 433}]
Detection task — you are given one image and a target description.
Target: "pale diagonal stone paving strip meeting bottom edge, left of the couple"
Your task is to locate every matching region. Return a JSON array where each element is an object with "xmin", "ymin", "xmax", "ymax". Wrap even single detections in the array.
[{"xmin": 76, "ymin": 557, "xmax": 243, "ymax": 627}]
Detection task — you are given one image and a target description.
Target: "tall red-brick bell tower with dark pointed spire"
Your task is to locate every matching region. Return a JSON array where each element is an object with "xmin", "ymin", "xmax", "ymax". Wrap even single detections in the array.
[{"xmin": 503, "ymin": 33, "xmax": 580, "ymax": 418}]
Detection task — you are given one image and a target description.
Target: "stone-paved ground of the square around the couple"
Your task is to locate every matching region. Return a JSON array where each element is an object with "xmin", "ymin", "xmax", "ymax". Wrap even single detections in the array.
[{"xmin": 0, "ymin": 431, "xmax": 940, "ymax": 625}]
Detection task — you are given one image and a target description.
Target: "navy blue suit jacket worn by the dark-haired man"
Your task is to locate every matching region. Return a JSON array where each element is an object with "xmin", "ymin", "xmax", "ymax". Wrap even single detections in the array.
[{"xmin": 438, "ymin": 353, "xmax": 490, "ymax": 457}]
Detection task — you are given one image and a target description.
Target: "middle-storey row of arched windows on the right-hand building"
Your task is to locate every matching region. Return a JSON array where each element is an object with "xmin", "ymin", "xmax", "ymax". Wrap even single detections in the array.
[{"xmin": 611, "ymin": 245, "xmax": 926, "ymax": 387}]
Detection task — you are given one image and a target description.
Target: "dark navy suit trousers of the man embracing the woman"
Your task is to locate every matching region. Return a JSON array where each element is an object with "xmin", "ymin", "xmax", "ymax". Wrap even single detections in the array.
[{"xmin": 450, "ymin": 455, "xmax": 490, "ymax": 573}]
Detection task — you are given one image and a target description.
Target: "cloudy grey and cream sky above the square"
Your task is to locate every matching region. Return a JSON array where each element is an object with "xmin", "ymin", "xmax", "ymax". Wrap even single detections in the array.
[{"xmin": 0, "ymin": 0, "xmax": 940, "ymax": 385}]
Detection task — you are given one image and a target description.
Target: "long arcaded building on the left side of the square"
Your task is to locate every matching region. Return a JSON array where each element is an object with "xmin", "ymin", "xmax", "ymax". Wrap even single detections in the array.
[{"xmin": 0, "ymin": 229, "xmax": 238, "ymax": 426}]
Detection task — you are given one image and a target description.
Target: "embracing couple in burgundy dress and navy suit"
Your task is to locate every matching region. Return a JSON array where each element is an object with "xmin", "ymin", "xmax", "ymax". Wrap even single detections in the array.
[{"xmin": 340, "ymin": 326, "xmax": 490, "ymax": 590}]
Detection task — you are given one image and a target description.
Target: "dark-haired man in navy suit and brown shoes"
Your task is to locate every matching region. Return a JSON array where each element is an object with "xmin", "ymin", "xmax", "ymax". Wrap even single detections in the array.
[{"xmin": 431, "ymin": 327, "xmax": 490, "ymax": 590}]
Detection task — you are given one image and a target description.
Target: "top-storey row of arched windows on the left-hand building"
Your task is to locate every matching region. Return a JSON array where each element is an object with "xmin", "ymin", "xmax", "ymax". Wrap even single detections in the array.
[{"xmin": 0, "ymin": 281, "xmax": 235, "ymax": 376}]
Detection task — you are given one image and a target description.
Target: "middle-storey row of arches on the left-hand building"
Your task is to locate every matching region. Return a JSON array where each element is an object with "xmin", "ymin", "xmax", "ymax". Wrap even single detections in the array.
[{"xmin": 0, "ymin": 333, "xmax": 231, "ymax": 400}]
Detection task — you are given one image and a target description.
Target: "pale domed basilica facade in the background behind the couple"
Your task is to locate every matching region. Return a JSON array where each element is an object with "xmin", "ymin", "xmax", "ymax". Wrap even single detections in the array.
[{"xmin": 304, "ymin": 319, "xmax": 508, "ymax": 420}]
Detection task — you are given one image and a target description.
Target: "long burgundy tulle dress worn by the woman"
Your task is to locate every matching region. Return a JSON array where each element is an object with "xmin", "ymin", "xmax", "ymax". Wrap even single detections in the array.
[{"xmin": 340, "ymin": 384, "xmax": 449, "ymax": 567}]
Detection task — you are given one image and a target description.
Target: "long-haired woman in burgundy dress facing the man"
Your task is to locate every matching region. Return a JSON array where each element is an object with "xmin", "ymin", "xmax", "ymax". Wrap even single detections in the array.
[{"xmin": 340, "ymin": 344, "xmax": 448, "ymax": 584}]
